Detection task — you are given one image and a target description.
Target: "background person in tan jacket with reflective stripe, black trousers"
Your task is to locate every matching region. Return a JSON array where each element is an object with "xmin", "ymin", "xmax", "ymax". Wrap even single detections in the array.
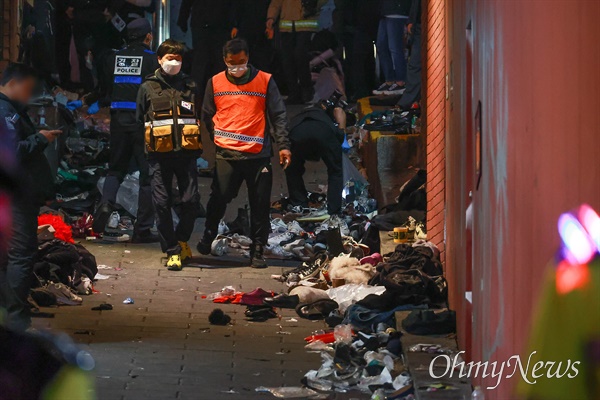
[{"xmin": 266, "ymin": 0, "xmax": 328, "ymax": 104}]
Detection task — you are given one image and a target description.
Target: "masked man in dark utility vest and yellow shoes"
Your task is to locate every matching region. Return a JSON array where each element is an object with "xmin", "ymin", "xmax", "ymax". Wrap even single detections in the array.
[{"xmin": 137, "ymin": 39, "xmax": 202, "ymax": 270}]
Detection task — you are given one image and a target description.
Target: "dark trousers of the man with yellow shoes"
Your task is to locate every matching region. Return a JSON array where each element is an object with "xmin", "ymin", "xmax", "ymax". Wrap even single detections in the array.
[{"xmin": 149, "ymin": 157, "xmax": 200, "ymax": 256}]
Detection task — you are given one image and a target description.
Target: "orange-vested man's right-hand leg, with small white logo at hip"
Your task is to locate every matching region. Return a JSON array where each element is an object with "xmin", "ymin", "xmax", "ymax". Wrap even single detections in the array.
[{"xmin": 243, "ymin": 158, "xmax": 273, "ymax": 268}]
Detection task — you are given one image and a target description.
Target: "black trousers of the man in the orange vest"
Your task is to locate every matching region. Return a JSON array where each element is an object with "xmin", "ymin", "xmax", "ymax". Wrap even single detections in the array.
[{"xmin": 204, "ymin": 158, "xmax": 273, "ymax": 245}]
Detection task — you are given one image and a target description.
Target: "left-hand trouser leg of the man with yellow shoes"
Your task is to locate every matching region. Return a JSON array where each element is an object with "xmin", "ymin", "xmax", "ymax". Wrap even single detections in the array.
[{"xmin": 149, "ymin": 159, "xmax": 181, "ymax": 257}]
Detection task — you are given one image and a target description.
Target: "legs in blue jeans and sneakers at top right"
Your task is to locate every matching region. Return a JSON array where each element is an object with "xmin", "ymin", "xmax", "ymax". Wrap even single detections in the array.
[{"xmin": 373, "ymin": 0, "xmax": 411, "ymax": 95}]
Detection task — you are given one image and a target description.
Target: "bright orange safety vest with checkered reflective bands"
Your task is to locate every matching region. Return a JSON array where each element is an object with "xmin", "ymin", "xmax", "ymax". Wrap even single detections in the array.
[{"xmin": 212, "ymin": 71, "xmax": 271, "ymax": 154}]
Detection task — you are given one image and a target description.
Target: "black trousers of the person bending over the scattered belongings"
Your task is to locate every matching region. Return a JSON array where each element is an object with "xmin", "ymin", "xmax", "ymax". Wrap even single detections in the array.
[{"xmin": 285, "ymin": 120, "xmax": 344, "ymax": 214}]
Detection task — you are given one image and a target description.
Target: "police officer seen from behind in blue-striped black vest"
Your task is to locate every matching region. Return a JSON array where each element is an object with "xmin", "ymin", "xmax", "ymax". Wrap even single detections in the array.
[{"xmin": 88, "ymin": 18, "xmax": 158, "ymax": 243}]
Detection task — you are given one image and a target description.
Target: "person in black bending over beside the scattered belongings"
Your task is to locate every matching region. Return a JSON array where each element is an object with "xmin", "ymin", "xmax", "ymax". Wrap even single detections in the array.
[{"xmin": 285, "ymin": 105, "xmax": 346, "ymax": 215}]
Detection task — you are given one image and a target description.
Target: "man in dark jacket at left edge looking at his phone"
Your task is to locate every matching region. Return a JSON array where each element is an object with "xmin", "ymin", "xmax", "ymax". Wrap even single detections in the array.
[{"xmin": 0, "ymin": 63, "xmax": 61, "ymax": 330}]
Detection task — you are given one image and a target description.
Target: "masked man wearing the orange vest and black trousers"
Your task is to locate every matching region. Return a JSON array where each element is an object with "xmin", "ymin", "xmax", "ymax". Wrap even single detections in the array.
[{"xmin": 198, "ymin": 39, "xmax": 291, "ymax": 268}]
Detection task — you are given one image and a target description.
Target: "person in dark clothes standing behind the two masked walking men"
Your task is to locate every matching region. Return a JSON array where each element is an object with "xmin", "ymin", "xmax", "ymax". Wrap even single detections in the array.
[{"xmin": 177, "ymin": 0, "xmax": 237, "ymax": 97}]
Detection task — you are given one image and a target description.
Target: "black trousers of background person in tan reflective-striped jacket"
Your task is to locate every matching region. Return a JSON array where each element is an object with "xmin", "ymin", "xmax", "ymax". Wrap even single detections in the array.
[{"xmin": 281, "ymin": 32, "xmax": 313, "ymax": 100}]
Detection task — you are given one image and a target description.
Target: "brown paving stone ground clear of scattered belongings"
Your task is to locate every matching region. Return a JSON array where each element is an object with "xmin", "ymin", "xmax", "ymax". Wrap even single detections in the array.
[{"xmin": 34, "ymin": 151, "xmax": 370, "ymax": 400}]
